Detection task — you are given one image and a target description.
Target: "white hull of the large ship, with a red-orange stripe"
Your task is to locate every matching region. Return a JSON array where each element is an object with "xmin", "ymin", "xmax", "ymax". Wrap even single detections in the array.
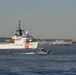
[{"xmin": 0, "ymin": 42, "xmax": 38, "ymax": 49}]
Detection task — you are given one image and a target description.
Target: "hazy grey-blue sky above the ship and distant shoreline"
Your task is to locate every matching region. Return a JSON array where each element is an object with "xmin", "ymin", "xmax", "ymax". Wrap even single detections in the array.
[{"xmin": 0, "ymin": 0, "xmax": 76, "ymax": 39}]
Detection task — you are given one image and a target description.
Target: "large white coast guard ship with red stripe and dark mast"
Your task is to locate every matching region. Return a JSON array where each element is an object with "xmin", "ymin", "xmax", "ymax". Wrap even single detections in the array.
[{"xmin": 0, "ymin": 20, "xmax": 38, "ymax": 49}]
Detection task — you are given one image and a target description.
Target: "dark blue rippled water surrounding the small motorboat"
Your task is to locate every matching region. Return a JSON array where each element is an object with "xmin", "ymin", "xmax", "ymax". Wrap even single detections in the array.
[{"xmin": 0, "ymin": 45, "xmax": 76, "ymax": 75}]
